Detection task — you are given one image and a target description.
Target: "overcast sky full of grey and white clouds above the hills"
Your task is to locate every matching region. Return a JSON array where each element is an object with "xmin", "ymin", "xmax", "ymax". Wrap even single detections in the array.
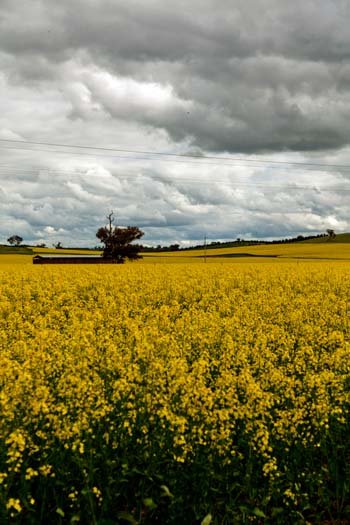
[{"xmin": 0, "ymin": 0, "xmax": 350, "ymax": 246}]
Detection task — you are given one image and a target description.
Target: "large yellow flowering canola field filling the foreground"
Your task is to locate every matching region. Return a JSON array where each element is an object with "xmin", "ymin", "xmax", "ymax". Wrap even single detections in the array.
[{"xmin": 0, "ymin": 256, "xmax": 350, "ymax": 525}]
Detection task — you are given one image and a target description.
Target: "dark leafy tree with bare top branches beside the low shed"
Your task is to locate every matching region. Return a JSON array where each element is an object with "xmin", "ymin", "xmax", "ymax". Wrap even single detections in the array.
[{"xmin": 96, "ymin": 212, "xmax": 144, "ymax": 264}]
